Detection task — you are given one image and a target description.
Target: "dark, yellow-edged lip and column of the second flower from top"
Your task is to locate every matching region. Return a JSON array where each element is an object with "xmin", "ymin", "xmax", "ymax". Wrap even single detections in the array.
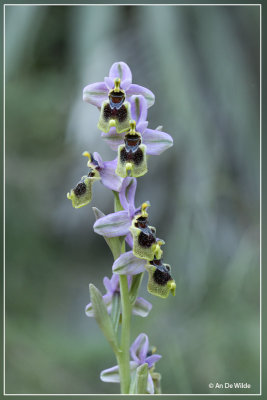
[{"xmin": 116, "ymin": 120, "xmax": 147, "ymax": 178}]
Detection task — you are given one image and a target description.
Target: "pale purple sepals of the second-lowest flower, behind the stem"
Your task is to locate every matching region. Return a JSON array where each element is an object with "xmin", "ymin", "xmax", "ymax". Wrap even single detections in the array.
[{"xmin": 85, "ymin": 274, "xmax": 152, "ymax": 317}]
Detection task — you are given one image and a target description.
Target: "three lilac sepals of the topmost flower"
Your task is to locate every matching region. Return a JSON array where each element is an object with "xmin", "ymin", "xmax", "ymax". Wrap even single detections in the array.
[{"xmin": 83, "ymin": 61, "xmax": 155, "ymax": 108}]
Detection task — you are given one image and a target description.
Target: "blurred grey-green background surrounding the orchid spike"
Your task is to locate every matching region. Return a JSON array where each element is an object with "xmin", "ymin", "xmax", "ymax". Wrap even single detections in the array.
[{"xmin": 5, "ymin": 6, "xmax": 260, "ymax": 393}]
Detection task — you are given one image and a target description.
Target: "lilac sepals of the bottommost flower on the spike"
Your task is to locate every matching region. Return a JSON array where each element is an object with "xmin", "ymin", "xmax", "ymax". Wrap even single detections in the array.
[{"xmin": 100, "ymin": 333, "xmax": 161, "ymax": 394}]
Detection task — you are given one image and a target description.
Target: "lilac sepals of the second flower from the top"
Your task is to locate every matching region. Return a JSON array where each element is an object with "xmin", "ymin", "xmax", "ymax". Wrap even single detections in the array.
[{"xmin": 101, "ymin": 96, "xmax": 173, "ymax": 156}]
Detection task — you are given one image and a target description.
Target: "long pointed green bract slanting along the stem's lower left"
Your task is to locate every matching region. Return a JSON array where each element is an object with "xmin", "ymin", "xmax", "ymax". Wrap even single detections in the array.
[{"xmin": 89, "ymin": 283, "xmax": 118, "ymax": 354}]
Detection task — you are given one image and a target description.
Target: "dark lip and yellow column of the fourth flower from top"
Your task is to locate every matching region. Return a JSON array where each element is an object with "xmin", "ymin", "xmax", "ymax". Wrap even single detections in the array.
[{"xmin": 130, "ymin": 202, "xmax": 164, "ymax": 260}]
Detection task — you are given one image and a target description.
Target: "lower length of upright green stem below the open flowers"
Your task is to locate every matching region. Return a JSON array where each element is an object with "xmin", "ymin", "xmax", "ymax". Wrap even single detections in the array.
[{"xmin": 118, "ymin": 275, "xmax": 132, "ymax": 394}]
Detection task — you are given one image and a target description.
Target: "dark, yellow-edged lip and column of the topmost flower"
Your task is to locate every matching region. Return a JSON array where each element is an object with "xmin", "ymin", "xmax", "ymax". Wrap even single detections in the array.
[{"xmin": 98, "ymin": 78, "xmax": 131, "ymax": 133}]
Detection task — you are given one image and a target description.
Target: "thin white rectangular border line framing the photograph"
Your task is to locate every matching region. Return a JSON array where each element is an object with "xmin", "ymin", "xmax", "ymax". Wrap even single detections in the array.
[{"xmin": 3, "ymin": 3, "xmax": 262, "ymax": 397}]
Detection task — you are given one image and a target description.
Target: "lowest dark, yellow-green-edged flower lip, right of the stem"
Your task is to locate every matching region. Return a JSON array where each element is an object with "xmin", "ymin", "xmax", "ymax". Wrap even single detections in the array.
[{"xmin": 146, "ymin": 259, "xmax": 176, "ymax": 299}]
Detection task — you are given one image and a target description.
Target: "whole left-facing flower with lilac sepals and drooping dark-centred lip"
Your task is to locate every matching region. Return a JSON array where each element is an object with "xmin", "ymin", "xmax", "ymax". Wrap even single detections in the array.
[{"xmin": 67, "ymin": 151, "xmax": 123, "ymax": 208}]
